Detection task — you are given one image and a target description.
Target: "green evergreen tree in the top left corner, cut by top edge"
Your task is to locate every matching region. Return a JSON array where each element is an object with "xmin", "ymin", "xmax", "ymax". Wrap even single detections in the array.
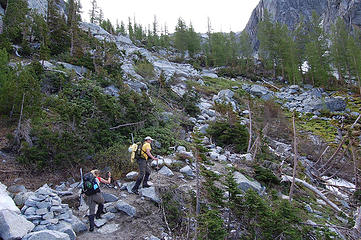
[{"xmin": 3, "ymin": 0, "xmax": 29, "ymax": 44}]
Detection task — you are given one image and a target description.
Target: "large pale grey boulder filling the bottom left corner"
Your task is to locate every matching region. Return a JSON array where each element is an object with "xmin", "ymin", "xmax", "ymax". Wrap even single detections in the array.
[{"xmin": 0, "ymin": 209, "xmax": 35, "ymax": 240}]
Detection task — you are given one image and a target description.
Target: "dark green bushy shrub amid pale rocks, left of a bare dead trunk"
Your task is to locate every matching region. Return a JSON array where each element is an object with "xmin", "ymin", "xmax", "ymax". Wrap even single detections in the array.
[{"xmin": 207, "ymin": 121, "xmax": 248, "ymax": 152}]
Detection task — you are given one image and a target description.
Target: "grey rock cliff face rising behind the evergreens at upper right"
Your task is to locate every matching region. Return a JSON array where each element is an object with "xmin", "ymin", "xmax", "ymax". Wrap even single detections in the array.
[{"xmin": 245, "ymin": 0, "xmax": 361, "ymax": 49}]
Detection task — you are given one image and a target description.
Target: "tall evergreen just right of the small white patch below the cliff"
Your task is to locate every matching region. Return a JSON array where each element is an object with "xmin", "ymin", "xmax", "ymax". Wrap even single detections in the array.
[{"xmin": 306, "ymin": 11, "xmax": 330, "ymax": 86}]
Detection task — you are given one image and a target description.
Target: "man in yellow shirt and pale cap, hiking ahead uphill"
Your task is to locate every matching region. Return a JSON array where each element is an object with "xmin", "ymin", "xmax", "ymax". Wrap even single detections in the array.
[{"xmin": 132, "ymin": 136, "xmax": 158, "ymax": 194}]
